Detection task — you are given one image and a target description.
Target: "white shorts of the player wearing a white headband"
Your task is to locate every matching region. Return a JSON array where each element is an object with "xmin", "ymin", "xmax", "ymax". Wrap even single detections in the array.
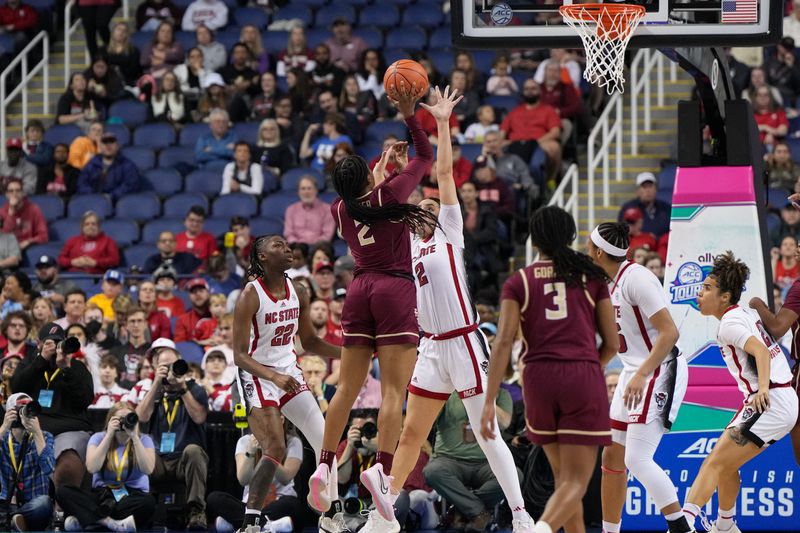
[{"xmin": 611, "ymin": 356, "xmax": 689, "ymax": 445}]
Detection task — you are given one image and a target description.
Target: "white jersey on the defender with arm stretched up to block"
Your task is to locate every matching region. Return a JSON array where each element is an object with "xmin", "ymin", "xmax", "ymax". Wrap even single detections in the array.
[{"xmin": 411, "ymin": 204, "xmax": 476, "ymax": 335}]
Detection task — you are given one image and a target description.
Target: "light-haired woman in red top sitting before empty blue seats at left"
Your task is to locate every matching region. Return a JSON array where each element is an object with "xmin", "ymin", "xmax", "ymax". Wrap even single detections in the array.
[{"xmin": 58, "ymin": 211, "xmax": 119, "ymax": 274}]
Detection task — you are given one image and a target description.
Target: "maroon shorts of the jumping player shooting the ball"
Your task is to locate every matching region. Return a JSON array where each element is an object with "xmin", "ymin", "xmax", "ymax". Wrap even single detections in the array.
[{"xmin": 342, "ymin": 272, "xmax": 419, "ymax": 347}]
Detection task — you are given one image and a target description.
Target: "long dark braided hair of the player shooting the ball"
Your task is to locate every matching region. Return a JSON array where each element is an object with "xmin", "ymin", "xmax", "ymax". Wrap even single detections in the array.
[{"xmin": 333, "ymin": 155, "xmax": 437, "ymax": 233}]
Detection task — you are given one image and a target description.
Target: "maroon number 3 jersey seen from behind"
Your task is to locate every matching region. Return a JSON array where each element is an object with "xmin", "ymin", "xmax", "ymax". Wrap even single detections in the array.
[{"xmin": 501, "ymin": 261, "xmax": 609, "ymax": 363}]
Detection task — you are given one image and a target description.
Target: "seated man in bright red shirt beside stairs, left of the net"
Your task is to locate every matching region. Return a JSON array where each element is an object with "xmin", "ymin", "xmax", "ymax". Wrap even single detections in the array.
[{"xmin": 500, "ymin": 79, "xmax": 561, "ymax": 180}]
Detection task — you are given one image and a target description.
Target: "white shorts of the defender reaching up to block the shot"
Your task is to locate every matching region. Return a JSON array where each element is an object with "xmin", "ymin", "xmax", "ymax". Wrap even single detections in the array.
[{"xmin": 408, "ymin": 330, "xmax": 489, "ymax": 400}]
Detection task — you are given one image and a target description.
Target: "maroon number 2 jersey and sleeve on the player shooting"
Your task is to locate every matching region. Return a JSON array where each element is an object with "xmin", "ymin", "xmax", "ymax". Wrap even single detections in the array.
[{"xmin": 331, "ymin": 117, "xmax": 433, "ymax": 279}]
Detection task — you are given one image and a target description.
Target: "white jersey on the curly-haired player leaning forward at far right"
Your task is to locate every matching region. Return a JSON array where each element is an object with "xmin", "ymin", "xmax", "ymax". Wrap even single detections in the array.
[{"xmin": 717, "ymin": 305, "xmax": 792, "ymax": 399}]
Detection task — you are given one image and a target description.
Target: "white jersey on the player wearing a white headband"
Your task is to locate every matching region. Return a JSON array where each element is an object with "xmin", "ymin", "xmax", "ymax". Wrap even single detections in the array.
[{"xmin": 608, "ymin": 261, "xmax": 667, "ymax": 371}]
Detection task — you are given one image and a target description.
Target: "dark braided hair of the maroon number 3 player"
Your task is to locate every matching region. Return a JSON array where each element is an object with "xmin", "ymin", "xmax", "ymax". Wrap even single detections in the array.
[{"xmin": 530, "ymin": 206, "xmax": 607, "ymax": 286}]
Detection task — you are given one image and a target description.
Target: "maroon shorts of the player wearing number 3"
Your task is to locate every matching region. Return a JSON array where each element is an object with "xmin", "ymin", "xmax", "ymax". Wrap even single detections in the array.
[{"xmin": 522, "ymin": 360, "xmax": 611, "ymax": 446}]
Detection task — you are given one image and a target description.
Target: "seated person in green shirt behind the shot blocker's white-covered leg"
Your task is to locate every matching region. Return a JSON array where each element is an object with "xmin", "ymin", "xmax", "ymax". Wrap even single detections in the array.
[{"xmin": 422, "ymin": 389, "xmax": 519, "ymax": 531}]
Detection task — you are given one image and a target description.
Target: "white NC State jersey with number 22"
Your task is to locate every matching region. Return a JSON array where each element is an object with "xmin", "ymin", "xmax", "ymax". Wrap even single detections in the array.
[{"xmin": 249, "ymin": 278, "xmax": 300, "ymax": 367}]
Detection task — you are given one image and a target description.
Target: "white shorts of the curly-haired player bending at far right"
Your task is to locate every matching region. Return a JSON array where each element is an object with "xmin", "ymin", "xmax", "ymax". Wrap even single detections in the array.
[{"xmin": 726, "ymin": 387, "xmax": 798, "ymax": 448}]
